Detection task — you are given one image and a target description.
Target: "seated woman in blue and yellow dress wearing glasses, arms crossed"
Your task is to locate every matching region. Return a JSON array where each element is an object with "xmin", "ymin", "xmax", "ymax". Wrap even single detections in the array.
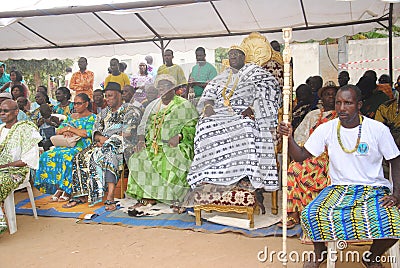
[{"xmin": 34, "ymin": 93, "xmax": 96, "ymax": 202}]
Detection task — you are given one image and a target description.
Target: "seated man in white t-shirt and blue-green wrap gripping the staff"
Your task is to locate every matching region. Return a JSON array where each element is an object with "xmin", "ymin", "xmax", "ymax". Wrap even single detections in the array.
[{"xmin": 279, "ymin": 85, "xmax": 400, "ymax": 267}]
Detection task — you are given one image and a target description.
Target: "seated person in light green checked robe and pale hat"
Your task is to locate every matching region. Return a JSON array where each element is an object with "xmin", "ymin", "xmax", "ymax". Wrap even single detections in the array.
[{"xmin": 126, "ymin": 74, "xmax": 198, "ymax": 208}]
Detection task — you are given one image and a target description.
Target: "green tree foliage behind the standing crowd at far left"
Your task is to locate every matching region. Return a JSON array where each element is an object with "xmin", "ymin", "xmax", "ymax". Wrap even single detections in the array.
[{"xmin": 5, "ymin": 59, "xmax": 74, "ymax": 99}]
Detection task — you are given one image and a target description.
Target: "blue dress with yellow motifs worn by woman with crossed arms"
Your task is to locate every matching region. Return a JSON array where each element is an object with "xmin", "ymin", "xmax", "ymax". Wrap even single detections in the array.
[{"xmin": 34, "ymin": 114, "xmax": 96, "ymax": 194}]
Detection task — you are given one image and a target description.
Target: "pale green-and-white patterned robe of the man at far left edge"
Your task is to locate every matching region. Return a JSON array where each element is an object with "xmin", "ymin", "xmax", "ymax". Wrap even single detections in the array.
[{"xmin": 0, "ymin": 121, "xmax": 42, "ymax": 233}]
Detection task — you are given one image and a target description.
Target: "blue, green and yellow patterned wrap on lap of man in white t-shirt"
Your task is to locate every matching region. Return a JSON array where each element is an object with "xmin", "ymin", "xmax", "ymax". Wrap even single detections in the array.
[{"xmin": 301, "ymin": 185, "xmax": 400, "ymax": 241}]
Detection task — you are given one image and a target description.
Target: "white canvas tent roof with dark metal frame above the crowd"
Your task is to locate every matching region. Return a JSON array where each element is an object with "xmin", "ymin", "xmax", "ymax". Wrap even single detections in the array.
[{"xmin": 0, "ymin": 0, "xmax": 400, "ymax": 59}]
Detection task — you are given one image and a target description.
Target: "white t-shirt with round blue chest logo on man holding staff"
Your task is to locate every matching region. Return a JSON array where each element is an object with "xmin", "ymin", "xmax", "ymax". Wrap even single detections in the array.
[{"xmin": 304, "ymin": 117, "xmax": 400, "ymax": 190}]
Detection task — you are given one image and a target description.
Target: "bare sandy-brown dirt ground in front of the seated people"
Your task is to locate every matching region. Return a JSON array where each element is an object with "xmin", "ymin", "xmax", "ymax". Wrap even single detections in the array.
[{"xmin": 0, "ymin": 193, "xmax": 390, "ymax": 268}]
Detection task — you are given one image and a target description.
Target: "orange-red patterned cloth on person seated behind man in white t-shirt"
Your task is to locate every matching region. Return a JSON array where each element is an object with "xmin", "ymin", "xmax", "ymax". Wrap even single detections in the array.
[{"xmin": 287, "ymin": 109, "xmax": 336, "ymax": 212}]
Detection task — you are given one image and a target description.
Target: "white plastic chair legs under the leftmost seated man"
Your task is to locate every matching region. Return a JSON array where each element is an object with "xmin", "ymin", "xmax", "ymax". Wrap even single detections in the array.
[{"xmin": 4, "ymin": 172, "xmax": 38, "ymax": 234}]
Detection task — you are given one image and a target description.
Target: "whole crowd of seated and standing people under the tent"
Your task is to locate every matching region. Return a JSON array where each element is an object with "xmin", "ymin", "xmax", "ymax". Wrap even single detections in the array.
[{"xmin": 0, "ymin": 43, "xmax": 400, "ymax": 267}]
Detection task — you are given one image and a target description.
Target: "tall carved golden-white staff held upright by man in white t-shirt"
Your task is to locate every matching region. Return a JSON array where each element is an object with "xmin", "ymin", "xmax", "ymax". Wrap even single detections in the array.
[{"xmin": 281, "ymin": 28, "xmax": 292, "ymax": 266}]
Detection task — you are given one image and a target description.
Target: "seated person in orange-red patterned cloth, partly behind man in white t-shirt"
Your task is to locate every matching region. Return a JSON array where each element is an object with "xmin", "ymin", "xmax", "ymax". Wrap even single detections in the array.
[{"xmin": 279, "ymin": 81, "xmax": 338, "ymax": 229}]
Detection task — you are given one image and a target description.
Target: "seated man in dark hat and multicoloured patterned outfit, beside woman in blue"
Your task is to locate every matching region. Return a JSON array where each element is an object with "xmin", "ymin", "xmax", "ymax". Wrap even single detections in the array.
[{"xmin": 63, "ymin": 82, "xmax": 136, "ymax": 211}]
